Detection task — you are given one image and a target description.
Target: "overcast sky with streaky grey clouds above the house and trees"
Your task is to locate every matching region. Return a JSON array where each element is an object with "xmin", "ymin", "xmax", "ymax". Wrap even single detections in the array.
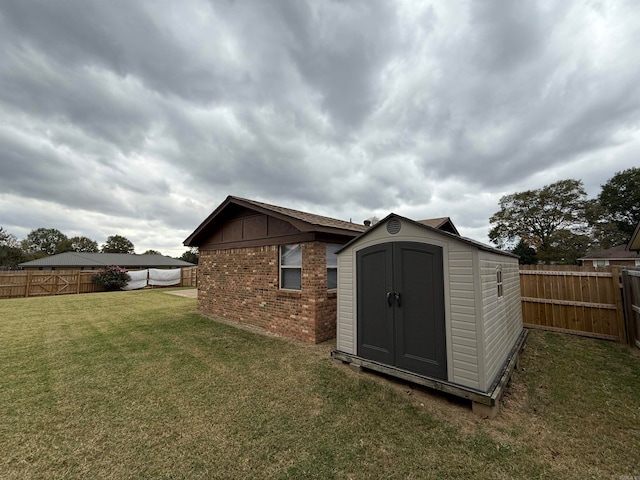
[{"xmin": 0, "ymin": 0, "xmax": 640, "ymax": 255}]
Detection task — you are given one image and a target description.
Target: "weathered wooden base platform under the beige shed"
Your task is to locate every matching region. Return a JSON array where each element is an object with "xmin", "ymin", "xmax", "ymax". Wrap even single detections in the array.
[{"xmin": 331, "ymin": 329, "xmax": 529, "ymax": 418}]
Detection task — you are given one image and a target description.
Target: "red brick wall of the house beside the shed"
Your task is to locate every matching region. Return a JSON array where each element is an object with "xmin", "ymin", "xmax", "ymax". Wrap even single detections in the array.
[{"xmin": 198, "ymin": 242, "xmax": 337, "ymax": 343}]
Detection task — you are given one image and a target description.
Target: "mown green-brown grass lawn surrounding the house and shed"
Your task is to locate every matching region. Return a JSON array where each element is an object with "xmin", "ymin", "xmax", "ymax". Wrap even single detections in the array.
[{"xmin": 0, "ymin": 290, "xmax": 640, "ymax": 480}]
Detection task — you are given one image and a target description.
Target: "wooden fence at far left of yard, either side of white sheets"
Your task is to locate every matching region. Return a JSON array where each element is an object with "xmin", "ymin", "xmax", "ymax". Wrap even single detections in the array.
[{"xmin": 0, "ymin": 267, "xmax": 198, "ymax": 298}]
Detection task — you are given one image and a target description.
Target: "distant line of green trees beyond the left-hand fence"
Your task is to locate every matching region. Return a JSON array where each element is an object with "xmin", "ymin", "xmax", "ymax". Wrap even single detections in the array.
[{"xmin": 0, "ymin": 226, "xmax": 198, "ymax": 268}]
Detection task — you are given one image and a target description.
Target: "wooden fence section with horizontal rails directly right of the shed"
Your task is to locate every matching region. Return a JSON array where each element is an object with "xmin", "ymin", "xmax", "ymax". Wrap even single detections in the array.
[{"xmin": 520, "ymin": 265, "xmax": 627, "ymax": 342}]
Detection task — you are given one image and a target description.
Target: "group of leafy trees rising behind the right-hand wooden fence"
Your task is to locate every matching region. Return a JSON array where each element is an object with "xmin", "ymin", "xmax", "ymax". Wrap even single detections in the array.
[{"xmin": 489, "ymin": 167, "xmax": 640, "ymax": 264}]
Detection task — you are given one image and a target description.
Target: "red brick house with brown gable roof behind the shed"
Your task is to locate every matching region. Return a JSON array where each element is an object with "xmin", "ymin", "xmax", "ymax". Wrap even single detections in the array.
[{"xmin": 184, "ymin": 196, "xmax": 455, "ymax": 343}]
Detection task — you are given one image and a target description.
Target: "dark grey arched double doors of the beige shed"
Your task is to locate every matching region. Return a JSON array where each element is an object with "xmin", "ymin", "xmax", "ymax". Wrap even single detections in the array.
[{"xmin": 356, "ymin": 242, "xmax": 447, "ymax": 380}]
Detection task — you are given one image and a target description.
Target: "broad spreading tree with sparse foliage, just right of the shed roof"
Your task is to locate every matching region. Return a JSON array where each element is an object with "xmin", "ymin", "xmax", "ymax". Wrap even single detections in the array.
[{"xmin": 489, "ymin": 179, "xmax": 586, "ymax": 259}]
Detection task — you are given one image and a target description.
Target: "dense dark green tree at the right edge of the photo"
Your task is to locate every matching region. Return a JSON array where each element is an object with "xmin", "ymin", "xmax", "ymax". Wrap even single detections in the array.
[{"xmin": 588, "ymin": 167, "xmax": 640, "ymax": 248}]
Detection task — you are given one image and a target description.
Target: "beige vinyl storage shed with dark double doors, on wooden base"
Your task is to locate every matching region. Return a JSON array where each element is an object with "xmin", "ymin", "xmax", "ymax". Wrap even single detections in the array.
[{"xmin": 332, "ymin": 214, "xmax": 526, "ymax": 416}]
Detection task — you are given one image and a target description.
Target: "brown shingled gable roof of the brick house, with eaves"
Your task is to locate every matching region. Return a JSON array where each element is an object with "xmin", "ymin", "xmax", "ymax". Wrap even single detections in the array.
[{"xmin": 183, "ymin": 195, "xmax": 458, "ymax": 246}]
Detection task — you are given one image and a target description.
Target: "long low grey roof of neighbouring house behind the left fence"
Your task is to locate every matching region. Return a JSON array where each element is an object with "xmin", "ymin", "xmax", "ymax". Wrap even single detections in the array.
[{"xmin": 20, "ymin": 252, "xmax": 195, "ymax": 268}]
